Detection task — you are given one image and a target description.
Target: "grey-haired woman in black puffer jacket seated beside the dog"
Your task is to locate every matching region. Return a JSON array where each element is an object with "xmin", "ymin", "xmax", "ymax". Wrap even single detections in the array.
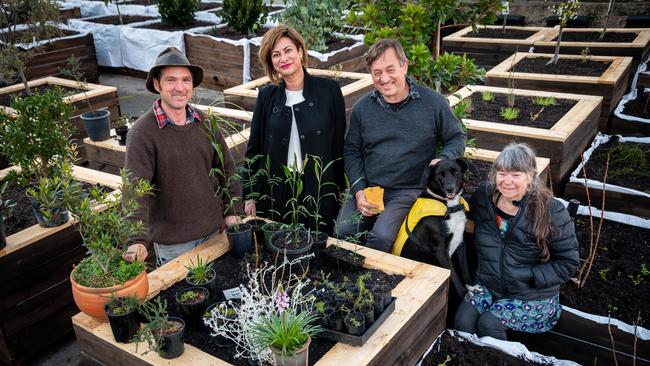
[{"xmin": 455, "ymin": 143, "xmax": 579, "ymax": 340}]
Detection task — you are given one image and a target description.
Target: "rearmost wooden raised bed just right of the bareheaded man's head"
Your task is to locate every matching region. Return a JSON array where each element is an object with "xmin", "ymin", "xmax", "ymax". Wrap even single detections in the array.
[{"xmin": 442, "ymin": 25, "xmax": 551, "ymax": 69}]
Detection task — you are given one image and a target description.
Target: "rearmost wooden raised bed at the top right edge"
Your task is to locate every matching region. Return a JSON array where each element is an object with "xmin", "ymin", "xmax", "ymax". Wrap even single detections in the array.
[{"xmin": 535, "ymin": 28, "xmax": 650, "ymax": 70}]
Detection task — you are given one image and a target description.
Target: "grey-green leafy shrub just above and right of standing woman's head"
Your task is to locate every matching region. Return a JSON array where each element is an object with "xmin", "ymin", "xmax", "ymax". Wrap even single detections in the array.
[{"xmin": 278, "ymin": 0, "xmax": 350, "ymax": 52}]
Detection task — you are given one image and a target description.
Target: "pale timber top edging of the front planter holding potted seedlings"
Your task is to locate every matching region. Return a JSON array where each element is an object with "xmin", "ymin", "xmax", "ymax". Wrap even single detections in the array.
[{"xmin": 72, "ymin": 234, "xmax": 449, "ymax": 365}]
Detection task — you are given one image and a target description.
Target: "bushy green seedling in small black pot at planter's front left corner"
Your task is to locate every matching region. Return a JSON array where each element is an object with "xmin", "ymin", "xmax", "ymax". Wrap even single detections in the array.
[{"xmin": 134, "ymin": 298, "xmax": 185, "ymax": 359}]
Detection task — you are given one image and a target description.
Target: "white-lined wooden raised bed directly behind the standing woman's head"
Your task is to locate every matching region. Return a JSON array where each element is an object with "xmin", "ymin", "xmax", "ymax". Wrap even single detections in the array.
[{"xmin": 250, "ymin": 36, "xmax": 368, "ymax": 79}]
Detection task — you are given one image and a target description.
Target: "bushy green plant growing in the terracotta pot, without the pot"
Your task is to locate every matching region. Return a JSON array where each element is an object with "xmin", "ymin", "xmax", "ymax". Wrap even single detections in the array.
[{"xmin": 68, "ymin": 170, "xmax": 153, "ymax": 287}]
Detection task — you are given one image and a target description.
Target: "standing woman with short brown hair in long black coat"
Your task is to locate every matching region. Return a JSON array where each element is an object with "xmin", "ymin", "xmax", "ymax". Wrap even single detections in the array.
[{"xmin": 246, "ymin": 25, "xmax": 345, "ymax": 234}]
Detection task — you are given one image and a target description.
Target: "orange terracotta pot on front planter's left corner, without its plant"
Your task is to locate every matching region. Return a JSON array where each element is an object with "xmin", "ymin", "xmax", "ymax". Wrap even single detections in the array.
[{"xmin": 70, "ymin": 270, "xmax": 149, "ymax": 322}]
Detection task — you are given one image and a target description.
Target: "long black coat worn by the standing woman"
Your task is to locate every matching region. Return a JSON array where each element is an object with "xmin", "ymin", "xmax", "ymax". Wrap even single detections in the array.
[{"xmin": 245, "ymin": 70, "xmax": 345, "ymax": 234}]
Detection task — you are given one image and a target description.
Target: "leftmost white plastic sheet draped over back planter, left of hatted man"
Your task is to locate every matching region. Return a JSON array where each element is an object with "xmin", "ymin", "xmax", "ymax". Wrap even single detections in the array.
[{"xmin": 68, "ymin": 13, "xmax": 158, "ymax": 67}]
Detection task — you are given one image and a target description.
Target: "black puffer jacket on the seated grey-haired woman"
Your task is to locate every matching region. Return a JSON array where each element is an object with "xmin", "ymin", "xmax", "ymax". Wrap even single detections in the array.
[{"xmin": 470, "ymin": 183, "xmax": 580, "ymax": 300}]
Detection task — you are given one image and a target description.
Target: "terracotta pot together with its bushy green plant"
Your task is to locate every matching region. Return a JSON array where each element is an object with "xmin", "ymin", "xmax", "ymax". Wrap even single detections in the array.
[{"xmin": 70, "ymin": 170, "xmax": 153, "ymax": 321}]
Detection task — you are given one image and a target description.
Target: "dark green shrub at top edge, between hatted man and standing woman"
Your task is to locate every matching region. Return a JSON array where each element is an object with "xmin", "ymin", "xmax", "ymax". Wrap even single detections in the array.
[{"xmin": 219, "ymin": 0, "xmax": 269, "ymax": 35}]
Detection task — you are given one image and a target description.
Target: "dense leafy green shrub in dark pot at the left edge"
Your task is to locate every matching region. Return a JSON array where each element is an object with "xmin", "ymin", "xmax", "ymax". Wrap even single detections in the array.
[{"xmin": 0, "ymin": 88, "xmax": 75, "ymax": 227}]
